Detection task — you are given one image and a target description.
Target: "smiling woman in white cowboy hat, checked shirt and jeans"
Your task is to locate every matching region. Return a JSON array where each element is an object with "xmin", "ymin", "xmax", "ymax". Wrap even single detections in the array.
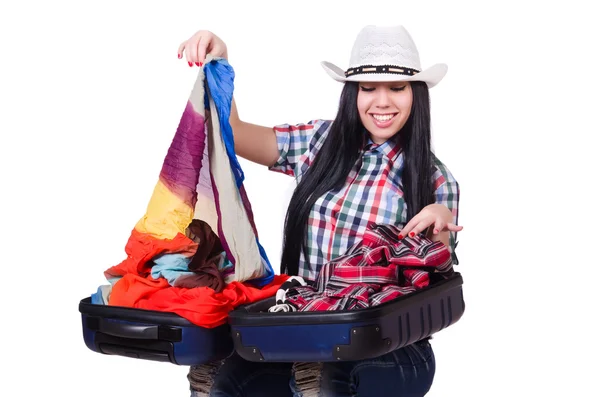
[{"xmin": 178, "ymin": 26, "xmax": 462, "ymax": 397}]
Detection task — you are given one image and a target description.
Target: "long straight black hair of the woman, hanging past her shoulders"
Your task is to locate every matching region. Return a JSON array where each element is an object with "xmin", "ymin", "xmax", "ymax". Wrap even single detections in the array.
[{"xmin": 281, "ymin": 82, "xmax": 434, "ymax": 275}]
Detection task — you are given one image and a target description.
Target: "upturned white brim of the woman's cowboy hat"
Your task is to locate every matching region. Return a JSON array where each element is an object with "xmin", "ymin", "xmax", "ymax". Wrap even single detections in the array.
[{"xmin": 321, "ymin": 61, "xmax": 448, "ymax": 88}]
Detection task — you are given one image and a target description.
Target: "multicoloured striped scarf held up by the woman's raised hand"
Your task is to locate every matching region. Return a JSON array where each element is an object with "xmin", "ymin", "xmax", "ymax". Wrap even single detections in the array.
[{"xmin": 105, "ymin": 56, "xmax": 274, "ymax": 299}]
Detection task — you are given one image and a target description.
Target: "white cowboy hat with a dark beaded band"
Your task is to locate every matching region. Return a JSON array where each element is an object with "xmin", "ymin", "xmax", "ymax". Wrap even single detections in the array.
[{"xmin": 321, "ymin": 25, "xmax": 448, "ymax": 88}]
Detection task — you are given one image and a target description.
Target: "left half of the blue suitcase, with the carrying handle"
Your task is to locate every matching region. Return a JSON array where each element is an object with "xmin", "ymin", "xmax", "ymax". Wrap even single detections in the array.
[{"xmin": 79, "ymin": 297, "xmax": 233, "ymax": 365}]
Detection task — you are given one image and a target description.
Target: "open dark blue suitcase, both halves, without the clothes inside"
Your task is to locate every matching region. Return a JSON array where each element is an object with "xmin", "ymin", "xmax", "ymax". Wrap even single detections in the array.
[{"xmin": 79, "ymin": 273, "xmax": 465, "ymax": 365}]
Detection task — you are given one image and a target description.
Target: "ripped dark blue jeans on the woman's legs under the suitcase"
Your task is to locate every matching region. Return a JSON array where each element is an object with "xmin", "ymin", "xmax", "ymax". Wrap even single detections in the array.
[{"xmin": 190, "ymin": 340, "xmax": 435, "ymax": 397}]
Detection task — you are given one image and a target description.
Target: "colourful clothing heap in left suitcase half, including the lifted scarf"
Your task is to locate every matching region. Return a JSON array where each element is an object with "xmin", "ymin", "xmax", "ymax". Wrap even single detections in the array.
[{"xmin": 92, "ymin": 56, "xmax": 287, "ymax": 328}]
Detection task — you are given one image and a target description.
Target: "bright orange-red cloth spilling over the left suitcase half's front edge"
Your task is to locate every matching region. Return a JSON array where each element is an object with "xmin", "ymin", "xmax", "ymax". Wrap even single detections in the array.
[{"xmin": 109, "ymin": 274, "xmax": 289, "ymax": 328}]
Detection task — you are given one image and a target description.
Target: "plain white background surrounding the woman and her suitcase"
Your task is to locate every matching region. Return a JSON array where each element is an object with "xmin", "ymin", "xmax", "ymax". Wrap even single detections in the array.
[{"xmin": 0, "ymin": 0, "xmax": 600, "ymax": 397}]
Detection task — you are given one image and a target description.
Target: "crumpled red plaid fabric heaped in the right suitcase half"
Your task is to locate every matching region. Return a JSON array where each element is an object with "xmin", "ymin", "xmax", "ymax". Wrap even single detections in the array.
[{"xmin": 285, "ymin": 224, "xmax": 453, "ymax": 311}]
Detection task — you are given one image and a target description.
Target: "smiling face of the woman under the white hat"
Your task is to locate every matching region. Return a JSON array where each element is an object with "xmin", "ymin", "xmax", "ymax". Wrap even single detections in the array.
[{"xmin": 356, "ymin": 82, "xmax": 413, "ymax": 144}]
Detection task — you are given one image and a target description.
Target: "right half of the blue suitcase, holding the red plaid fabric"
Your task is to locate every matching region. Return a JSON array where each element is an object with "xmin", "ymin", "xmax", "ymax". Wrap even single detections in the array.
[{"xmin": 229, "ymin": 272, "xmax": 465, "ymax": 362}]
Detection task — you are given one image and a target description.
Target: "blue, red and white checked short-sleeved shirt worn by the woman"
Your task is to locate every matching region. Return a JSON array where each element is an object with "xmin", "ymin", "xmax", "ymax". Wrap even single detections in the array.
[{"xmin": 270, "ymin": 120, "xmax": 459, "ymax": 281}]
